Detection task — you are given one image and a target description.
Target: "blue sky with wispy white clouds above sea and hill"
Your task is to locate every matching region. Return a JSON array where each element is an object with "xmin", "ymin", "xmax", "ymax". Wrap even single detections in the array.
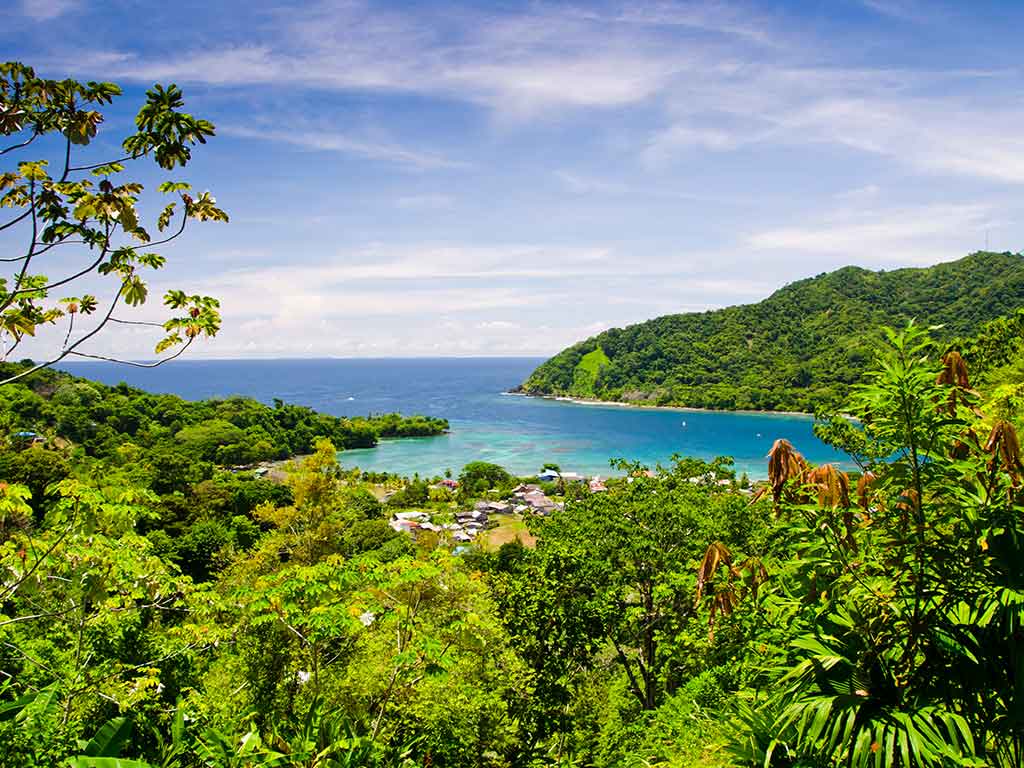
[{"xmin": 0, "ymin": 0, "xmax": 1024, "ymax": 358}]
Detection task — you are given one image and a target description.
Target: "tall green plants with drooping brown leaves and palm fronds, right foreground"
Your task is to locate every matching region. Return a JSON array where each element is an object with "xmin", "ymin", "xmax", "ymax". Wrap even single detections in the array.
[{"xmin": 736, "ymin": 325, "xmax": 1024, "ymax": 768}]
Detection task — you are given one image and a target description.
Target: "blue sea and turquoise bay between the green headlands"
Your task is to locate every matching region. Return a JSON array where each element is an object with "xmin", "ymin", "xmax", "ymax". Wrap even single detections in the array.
[{"xmin": 63, "ymin": 357, "xmax": 842, "ymax": 478}]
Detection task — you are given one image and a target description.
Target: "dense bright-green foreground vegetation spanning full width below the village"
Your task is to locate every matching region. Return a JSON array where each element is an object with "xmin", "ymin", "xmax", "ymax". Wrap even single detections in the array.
[{"xmin": 0, "ymin": 318, "xmax": 1024, "ymax": 768}]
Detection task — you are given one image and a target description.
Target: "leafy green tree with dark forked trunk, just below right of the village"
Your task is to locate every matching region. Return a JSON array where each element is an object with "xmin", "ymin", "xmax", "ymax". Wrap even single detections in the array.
[{"xmin": 531, "ymin": 461, "xmax": 763, "ymax": 710}]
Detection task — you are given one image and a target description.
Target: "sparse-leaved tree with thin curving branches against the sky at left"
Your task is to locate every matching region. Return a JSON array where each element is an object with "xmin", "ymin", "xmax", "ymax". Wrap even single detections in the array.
[{"xmin": 0, "ymin": 61, "xmax": 227, "ymax": 384}]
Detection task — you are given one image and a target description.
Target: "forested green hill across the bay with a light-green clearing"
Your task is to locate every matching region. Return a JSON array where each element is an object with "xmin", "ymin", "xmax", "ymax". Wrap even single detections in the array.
[{"xmin": 517, "ymin": 252, "xmax": 1024, "ymax": 411}]
